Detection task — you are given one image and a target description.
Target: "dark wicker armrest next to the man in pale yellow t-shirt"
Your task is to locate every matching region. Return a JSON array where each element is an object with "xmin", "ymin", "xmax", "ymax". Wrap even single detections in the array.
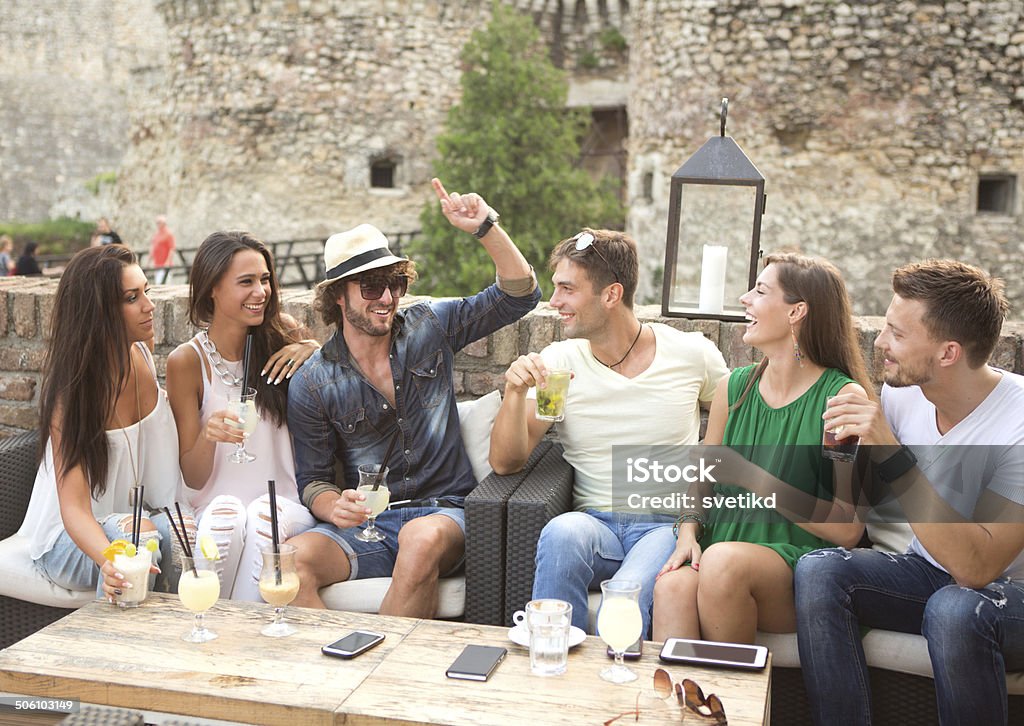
[{"xmin": 503, "ymin": 443, "xmax": 575, "ymax": 625}]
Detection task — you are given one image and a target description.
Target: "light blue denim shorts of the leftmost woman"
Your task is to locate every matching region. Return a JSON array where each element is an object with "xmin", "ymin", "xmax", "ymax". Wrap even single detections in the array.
[{"xmin": 35, "ymin": 513, "xmax": 177, "ymax": 599}]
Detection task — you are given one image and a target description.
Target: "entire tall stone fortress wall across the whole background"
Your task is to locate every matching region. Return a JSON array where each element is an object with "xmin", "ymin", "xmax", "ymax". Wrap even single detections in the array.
[{"xmin": 0, "ymin": 0, "xmax": 1024, "ymax": 315}]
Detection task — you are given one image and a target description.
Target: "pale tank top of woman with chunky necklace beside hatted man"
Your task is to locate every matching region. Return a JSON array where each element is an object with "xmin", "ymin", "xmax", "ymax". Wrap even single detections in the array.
[{"xmin": 188, "ymin": 336, "xmax": 299, "ymax": 514}]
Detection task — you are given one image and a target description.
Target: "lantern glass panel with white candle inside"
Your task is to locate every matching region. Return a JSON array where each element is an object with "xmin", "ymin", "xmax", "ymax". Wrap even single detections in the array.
[{"xmin": 669, "ymin": 183, "xmax": 757, "ymax": 315}]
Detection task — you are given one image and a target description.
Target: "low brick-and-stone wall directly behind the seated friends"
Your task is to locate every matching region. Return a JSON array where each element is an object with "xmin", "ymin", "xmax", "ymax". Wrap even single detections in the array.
[{"xmin": 0, "ymin": 277, "xmax": 1024, "ymax": 435}]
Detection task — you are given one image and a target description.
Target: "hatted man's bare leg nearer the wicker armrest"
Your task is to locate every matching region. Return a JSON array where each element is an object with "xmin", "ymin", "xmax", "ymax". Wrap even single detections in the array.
[{"xmin": 380, "ymin": 514, "xmax": 466, "ymax": 617}]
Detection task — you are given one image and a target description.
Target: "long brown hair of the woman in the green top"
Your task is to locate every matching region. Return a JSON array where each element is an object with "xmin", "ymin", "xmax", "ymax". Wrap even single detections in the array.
[{"xmin": 730, "ymin": 253, "xmax": 874, "ymax": 410}]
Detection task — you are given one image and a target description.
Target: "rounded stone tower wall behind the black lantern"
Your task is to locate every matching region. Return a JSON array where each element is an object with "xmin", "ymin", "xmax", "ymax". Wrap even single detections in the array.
[{"xmin": 629, "ymin": 0, "xmax": 1024, "ymax": 315}]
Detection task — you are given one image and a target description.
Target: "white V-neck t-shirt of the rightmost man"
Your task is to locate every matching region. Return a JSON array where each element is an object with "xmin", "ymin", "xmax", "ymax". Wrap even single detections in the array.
[{"xmin": 882, "ymin": 364, "xmax": 1024, "ymax": 580}]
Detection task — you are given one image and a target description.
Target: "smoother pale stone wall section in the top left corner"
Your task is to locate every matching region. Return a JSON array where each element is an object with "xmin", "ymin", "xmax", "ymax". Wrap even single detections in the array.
[{"xmin": 0, "ymin": 0, "xmax": 166, "ymax": 232}]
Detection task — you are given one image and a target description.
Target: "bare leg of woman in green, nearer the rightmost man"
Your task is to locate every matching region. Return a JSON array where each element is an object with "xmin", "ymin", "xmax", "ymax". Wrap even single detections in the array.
[{"xmin": 697, "ymin": 542, "xmax": 797, "ymax": 643}]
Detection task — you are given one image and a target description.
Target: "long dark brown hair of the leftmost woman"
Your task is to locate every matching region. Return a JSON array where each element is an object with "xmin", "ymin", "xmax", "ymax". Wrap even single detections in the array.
[{"xmin": 39, "ymin": 245, "xmax": 137, "ymax": 499}]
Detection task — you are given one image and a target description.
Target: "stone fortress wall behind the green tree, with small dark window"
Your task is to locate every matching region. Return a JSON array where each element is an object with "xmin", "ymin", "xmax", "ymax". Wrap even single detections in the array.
[{"xmin": 119, "ymin": 0, "xmax": 624, "ymax": 246}]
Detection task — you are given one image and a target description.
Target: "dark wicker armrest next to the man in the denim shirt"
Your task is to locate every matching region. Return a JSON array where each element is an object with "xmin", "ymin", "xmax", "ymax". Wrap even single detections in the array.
[{"xmin": 464, "ymin": 441, "xmax": 551, "ymax": 626}]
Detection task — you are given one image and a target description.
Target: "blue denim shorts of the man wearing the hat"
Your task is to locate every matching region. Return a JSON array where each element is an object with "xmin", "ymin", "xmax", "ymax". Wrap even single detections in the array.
[{"xmin": 309, "ymin": 497, "xmax": 466, "ymax": 580}]
